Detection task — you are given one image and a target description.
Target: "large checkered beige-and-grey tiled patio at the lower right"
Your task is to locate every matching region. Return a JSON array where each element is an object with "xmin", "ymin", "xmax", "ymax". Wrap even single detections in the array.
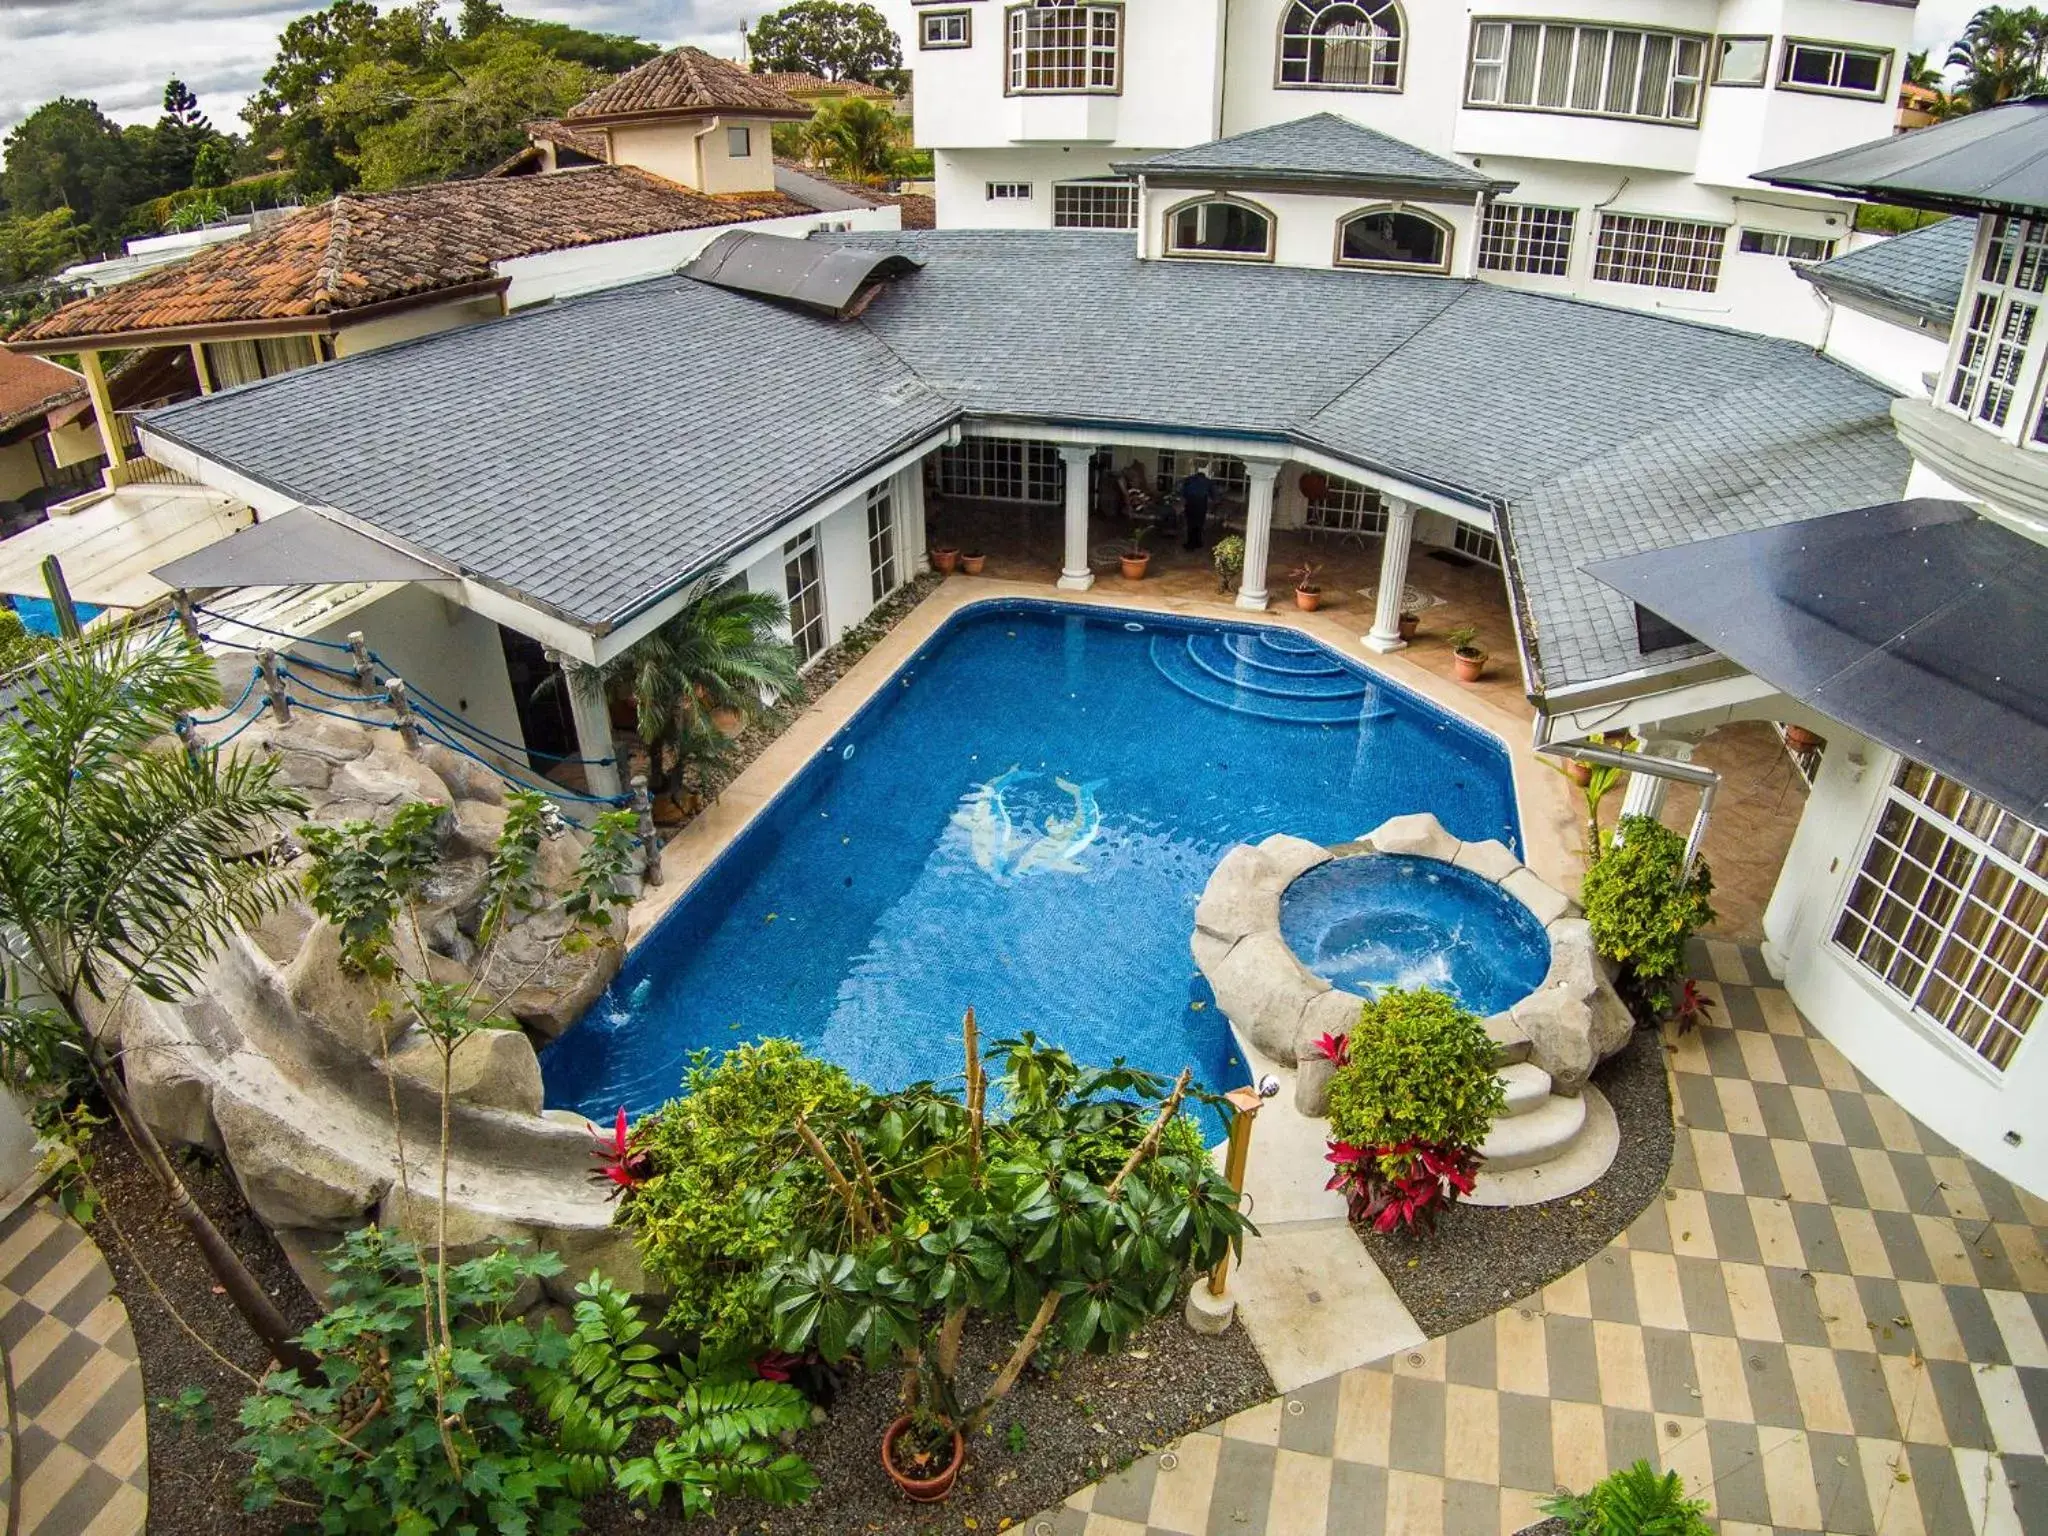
[{"xmin": 1040, "ymin": 942, "xmax": 2048, "ymax": 1536}]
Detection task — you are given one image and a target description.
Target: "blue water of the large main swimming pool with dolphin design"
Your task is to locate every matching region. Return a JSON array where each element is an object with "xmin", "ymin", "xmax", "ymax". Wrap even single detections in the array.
[{"xmin": 541, "ymin": 602, "xmax": 1518, "ymax": 1118}]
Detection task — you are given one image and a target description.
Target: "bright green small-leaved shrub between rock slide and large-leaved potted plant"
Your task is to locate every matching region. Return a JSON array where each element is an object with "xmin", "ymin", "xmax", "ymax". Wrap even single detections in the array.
[{"xmin": 623, "ymin": 1040, "xmax": 866, "ymax": 1348}]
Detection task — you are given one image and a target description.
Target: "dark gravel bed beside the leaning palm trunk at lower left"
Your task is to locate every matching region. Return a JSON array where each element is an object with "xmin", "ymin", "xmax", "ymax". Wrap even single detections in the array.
[{"xmin": 88, "ymin": 1124, "xmax": 319, "ymax": 1536}]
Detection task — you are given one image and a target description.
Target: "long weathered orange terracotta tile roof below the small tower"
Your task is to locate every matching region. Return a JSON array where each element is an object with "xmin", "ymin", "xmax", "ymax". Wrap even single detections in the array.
[{"xmin": 8, "ymin": 166, "xmax": 813, "ymax": 344}]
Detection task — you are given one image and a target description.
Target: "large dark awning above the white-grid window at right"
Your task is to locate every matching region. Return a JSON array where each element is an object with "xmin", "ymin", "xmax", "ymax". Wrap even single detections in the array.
[{"xmin": 1585, "ymin": 500, "xmax": 2048, "ymax": 825}]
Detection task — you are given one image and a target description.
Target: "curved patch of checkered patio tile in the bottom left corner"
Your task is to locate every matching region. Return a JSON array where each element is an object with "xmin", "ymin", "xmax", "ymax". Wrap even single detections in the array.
[{"xmin": 0, "ymin": 1198, "xmax": 150, "ymax": 1536}]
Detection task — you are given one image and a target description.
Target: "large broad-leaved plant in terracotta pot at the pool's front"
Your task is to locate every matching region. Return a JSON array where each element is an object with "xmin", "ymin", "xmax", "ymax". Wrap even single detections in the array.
[{"xmin": 764, "ymin": 1012, "xmax": 1249, "ymax": 1499}]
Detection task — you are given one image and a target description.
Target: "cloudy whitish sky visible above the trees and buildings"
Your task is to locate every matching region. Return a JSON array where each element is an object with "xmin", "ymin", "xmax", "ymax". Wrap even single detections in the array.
[{"xmin": 0, "ymin": 0, "xmax": 1978, "ymax": 131}]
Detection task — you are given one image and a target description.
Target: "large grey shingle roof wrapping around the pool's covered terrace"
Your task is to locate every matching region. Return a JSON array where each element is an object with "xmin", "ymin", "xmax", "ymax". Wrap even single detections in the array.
[{"xmin": 150, "ymin": 229, "xmax": 1909, "ymax": 688}]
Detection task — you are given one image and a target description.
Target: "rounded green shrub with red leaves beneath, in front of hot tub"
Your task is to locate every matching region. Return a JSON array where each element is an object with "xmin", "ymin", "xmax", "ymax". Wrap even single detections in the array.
[{"xmin": 1317, "ymin": 989, "xmax": 1507, "ymax": 1233}]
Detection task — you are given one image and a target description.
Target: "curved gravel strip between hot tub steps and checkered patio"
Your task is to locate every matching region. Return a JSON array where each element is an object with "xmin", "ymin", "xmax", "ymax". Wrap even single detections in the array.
[{"xmin": 1358, "ymin": 1028, "xmax": 1671, "ymax": 1339}]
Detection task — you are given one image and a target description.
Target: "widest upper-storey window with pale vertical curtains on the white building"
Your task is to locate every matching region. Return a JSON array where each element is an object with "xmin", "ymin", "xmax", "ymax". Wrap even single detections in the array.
[{"xmin": 1464, "ymin": 20, "xmax": 1708, "ymax": 127}]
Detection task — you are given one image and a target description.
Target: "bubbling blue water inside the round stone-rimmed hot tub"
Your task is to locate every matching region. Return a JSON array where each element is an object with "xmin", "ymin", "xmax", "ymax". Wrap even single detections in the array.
[{"xmin": 1280, "ymin": 854, "xmax": 1550, "ymax": 1016}]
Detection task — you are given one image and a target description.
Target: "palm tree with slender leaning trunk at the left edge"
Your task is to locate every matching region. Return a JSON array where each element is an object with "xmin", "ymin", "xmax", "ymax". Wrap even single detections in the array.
[{"xmin": 0, "ymin": 631, "xmax": 311, "ymax": 1366}]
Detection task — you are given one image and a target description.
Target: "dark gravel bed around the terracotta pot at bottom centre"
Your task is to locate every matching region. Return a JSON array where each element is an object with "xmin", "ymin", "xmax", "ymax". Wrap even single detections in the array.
[{"xmin": 584, "ymin": 1307, "xmax": 1274, "ymax": 1536}]
